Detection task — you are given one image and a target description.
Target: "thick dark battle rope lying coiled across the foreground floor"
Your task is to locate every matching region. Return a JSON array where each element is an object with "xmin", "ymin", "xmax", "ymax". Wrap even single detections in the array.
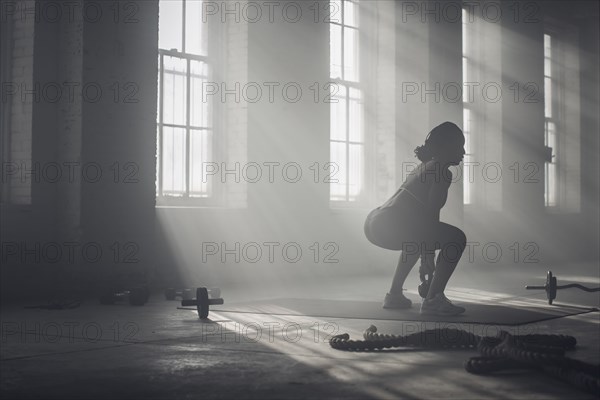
[{"xmin": 329, "ymin": 325, "xmax": 600, "ymax": 395}]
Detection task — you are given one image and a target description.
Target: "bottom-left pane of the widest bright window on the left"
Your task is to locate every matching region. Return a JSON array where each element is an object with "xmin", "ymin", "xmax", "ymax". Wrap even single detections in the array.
[{"xmin": 162, "ymin": 126, "xmax": 186, "ymax": 196}]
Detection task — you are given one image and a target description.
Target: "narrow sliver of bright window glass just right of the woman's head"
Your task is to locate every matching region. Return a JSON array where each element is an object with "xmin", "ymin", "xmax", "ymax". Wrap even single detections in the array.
[{"xmin": 462, "ymin": 9, "xmax": 474, "ymax": 204}]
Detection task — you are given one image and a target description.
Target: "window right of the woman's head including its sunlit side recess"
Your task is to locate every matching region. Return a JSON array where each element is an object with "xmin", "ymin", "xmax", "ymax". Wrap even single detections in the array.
[{"xmin": 462, "ymin": 7, "xmax": 506, "ymax": 212}]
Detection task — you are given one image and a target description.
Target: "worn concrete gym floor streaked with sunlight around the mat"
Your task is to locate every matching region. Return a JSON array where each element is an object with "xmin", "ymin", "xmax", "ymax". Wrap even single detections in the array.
[{"xmin": 0, "ymin": 265, "xmax": 600, "ymax": 399}]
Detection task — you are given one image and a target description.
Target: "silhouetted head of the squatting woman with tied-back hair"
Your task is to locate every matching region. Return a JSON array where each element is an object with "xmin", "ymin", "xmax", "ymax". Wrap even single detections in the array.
[{"xmin": 415, "ymin": 122, "xmax": 465, "ymax": 165}]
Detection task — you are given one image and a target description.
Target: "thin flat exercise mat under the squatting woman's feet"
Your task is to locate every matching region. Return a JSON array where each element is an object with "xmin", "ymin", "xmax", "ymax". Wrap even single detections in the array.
[{"xmin": 211, "ymin": 298, "xmax": 598, "ymax": 325}]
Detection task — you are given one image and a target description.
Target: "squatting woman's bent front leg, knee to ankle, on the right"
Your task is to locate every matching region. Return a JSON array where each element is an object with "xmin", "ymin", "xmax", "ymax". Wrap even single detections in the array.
[{"xmin": 427, "ymin": 222, "xmax": 467, "ymax": 299}]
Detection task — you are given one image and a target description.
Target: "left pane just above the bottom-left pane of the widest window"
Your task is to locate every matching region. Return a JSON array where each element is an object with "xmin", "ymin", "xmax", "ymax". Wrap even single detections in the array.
[{"xmin": 163, "ymin": 56, "xmax": 187, "ymax": 125}]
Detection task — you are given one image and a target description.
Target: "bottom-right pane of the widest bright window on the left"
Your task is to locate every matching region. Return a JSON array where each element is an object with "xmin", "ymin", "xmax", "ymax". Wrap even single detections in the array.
[{"xmin": 190, "ymin": 130, "xmax": 212, "ymax": 197}]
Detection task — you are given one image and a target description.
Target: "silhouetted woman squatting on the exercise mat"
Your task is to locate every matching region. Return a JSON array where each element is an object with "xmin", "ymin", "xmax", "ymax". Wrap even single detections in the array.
[{"xmin": 365, "ymin": 122, "xmax": 467, "ymax": 315}]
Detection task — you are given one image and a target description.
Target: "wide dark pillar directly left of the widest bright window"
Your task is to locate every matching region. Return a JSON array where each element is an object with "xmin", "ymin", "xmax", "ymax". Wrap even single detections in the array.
[{"xmin": 81, "ymin": 0, "xmax": 158, "ymax": 282}]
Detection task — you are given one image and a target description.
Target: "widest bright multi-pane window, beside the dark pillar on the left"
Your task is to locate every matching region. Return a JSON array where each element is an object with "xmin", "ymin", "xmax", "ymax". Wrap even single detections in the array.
[{"xmin": 156, "ymin": 0, "xmax": 214, "ymax": 202}]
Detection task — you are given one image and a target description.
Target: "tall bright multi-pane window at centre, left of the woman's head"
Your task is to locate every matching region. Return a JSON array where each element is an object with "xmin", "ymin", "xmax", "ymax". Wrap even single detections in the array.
[{"xmin": 329, "ymin": 0, "xmax": 365, "ymax": 202}]
